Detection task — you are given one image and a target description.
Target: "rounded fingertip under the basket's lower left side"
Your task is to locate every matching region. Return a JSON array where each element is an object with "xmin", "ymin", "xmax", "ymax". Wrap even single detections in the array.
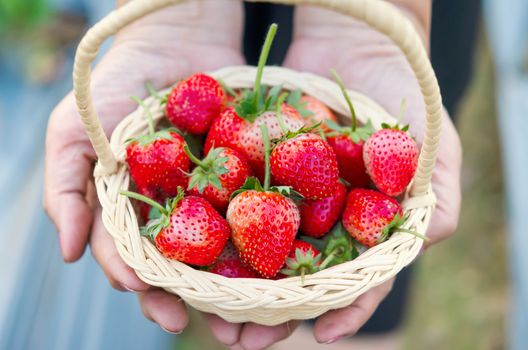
[{"xmin": 139, "ymin": 289, "xmax": 189, "ymax": 334}]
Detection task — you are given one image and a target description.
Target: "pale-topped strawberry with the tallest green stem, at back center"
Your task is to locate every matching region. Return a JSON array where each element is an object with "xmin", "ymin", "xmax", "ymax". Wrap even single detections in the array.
[{"xmin": 205, "ymin": 24, "xmax": 304, "ymax": 181}]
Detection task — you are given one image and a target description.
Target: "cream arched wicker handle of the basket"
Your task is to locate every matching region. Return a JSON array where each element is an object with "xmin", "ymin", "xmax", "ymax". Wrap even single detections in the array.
[{"xmin": 73, "ymin": 0, "xmax": 442, "ymax": 196}]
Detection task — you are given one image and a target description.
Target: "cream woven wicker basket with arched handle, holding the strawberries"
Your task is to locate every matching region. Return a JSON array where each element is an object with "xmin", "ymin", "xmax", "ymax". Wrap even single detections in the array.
[{"xmin": 70, "ymin": 0, "xmax": 442, "ymax": 325}]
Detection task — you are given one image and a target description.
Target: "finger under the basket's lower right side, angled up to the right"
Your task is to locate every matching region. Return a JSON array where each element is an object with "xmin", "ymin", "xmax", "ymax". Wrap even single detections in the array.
[{"xmin": 314, "ymin": 279, "xmax": 394, "ymax": 344}]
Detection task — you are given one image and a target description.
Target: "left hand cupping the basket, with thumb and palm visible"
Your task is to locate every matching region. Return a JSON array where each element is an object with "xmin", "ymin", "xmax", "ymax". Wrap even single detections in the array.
[{"xmin": 44, "ymin": 0, "xmax": 243, "ymax": 332}]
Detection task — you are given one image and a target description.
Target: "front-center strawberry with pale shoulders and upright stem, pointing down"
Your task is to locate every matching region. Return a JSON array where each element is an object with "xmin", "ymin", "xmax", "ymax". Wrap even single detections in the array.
[{"xmin": 227, "ymin": 124, "xmax": 301, "ymax": 278}]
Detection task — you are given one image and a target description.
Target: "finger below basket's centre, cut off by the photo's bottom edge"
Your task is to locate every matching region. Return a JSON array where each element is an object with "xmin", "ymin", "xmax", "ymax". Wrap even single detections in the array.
[{"xmin": 240, "ymin": 321, "xmax": 299, "ymax": 350}]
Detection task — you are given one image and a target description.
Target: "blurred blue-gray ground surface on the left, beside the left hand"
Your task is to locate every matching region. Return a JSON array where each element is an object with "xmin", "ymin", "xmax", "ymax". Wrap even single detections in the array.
[{"xmin": 0, "ymin": 0, "xmax": 172, "ymax": 350}]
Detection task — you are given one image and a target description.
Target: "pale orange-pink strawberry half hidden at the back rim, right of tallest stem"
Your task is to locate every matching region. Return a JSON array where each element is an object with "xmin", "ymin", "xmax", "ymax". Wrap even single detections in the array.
[{"xmin": 286, "ymin": 90, "xmax": 337, "ymax": 131}]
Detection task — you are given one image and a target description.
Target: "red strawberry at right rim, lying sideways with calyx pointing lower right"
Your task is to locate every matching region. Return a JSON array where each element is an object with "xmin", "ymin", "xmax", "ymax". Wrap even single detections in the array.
[{"xmin": 343, "ymin": 188, "xmax": 404, "ymax": 247}]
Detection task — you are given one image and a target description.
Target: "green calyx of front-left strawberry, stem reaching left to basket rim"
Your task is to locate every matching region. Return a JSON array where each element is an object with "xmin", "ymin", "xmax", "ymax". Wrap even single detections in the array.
[{"xmin": 119, "ymin": 187, "xmax": 185, "ymax": 239}]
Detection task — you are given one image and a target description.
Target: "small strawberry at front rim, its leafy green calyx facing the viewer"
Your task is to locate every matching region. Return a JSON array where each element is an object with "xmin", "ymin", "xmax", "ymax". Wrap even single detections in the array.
[{"xmin": 281, "ymin": 239, "xmax": 322, "ymax": 281}]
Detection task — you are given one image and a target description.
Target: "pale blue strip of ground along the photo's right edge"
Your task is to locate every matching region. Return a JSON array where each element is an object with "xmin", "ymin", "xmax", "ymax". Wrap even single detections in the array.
[{"xmin": 485, "ymin": 0, "xmax": 528, "ymax": 350}]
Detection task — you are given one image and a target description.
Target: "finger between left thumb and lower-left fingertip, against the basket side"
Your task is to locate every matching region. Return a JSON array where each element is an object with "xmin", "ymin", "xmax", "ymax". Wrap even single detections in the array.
[{"xmin": 90, "ymin": 208, "xmax": 149, "ymax": 292}]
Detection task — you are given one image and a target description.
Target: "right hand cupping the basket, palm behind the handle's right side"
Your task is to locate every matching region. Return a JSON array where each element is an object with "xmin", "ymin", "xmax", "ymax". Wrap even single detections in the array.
[{"xmin": 280, "ymin": 0, "xmax": 462, "ymax": 343}]
